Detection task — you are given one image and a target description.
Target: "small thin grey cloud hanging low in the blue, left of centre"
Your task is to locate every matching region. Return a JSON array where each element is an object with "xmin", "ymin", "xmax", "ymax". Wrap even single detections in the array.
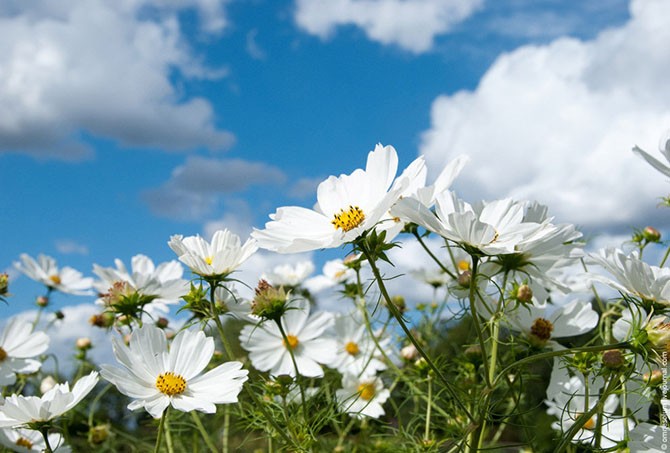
[{"xmin": 142, "ymin": 156, "xmax": 286, "ymax": 220}]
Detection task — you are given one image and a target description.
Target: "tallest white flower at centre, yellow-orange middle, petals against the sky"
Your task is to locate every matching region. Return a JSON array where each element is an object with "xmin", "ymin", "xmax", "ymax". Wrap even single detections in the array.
[{"xmin": 251, "ymin": 145, "xmax": 409, "ymax": 253}]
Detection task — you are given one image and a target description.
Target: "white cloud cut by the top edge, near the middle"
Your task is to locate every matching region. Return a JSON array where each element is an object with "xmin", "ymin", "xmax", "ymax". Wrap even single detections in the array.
[{"xmin": 294, "ymin": 0, "xmax": 483, "ymax": 53}]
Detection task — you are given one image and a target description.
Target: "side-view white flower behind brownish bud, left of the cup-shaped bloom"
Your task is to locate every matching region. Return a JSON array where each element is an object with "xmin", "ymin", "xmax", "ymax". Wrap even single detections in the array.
[{"xmin": 93, "ymin": 255, "xmax": 189, "ymax": 312}]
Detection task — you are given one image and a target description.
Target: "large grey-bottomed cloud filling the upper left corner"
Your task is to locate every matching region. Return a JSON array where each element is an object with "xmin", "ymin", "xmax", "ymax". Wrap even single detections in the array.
[{"xmin": 0, "ymin": 0, "xmax": 233, "ymax": 160}]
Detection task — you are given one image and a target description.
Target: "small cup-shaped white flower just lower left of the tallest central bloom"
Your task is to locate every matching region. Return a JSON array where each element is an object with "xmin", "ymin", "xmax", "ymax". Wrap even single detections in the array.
[{"xmin": 168, "ymin": 229, "xmax": 258, "ymax": 277}]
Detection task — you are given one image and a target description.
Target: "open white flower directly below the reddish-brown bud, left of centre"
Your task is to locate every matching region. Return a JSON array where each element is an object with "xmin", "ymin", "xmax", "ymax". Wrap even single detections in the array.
[{"xmin": 240, "ymin": 299, "xmax": 336, "ymax": 377}]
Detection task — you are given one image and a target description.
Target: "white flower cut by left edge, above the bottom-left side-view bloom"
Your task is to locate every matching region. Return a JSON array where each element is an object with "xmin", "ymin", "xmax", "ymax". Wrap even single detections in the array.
[{"xmin": 0, "ymin": 318, "xmax": 49, "ymax": 386}]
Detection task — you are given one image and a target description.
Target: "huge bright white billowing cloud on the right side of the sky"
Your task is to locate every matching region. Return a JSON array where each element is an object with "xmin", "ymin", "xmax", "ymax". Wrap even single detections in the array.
[{"xmin": 421, "ymin": 0, "xmax": 670, "ymax": 229}]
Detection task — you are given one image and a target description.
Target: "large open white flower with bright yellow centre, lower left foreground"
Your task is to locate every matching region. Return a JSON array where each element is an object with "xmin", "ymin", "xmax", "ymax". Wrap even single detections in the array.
[{"xmin": 101, "ymin": 324, "xmax": 249, "ymax": 418}]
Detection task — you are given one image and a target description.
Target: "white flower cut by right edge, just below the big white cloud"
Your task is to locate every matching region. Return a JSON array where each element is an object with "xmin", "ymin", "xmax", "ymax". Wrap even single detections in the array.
[{"xmin": 589, "ymin": 248, "xmax": 670, "ymax": 306}]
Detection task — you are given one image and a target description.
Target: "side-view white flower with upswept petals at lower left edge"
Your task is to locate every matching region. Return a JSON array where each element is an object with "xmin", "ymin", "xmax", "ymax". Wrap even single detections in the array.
[{"xmin": 0, "ymin": 371, "xmax": 98, "ymax": 428}]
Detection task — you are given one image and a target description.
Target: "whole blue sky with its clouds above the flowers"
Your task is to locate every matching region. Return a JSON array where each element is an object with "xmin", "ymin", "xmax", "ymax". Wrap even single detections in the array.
[{"xmin": 0, "ymin": 0, "xmax": 670, "ymax": 313}]
